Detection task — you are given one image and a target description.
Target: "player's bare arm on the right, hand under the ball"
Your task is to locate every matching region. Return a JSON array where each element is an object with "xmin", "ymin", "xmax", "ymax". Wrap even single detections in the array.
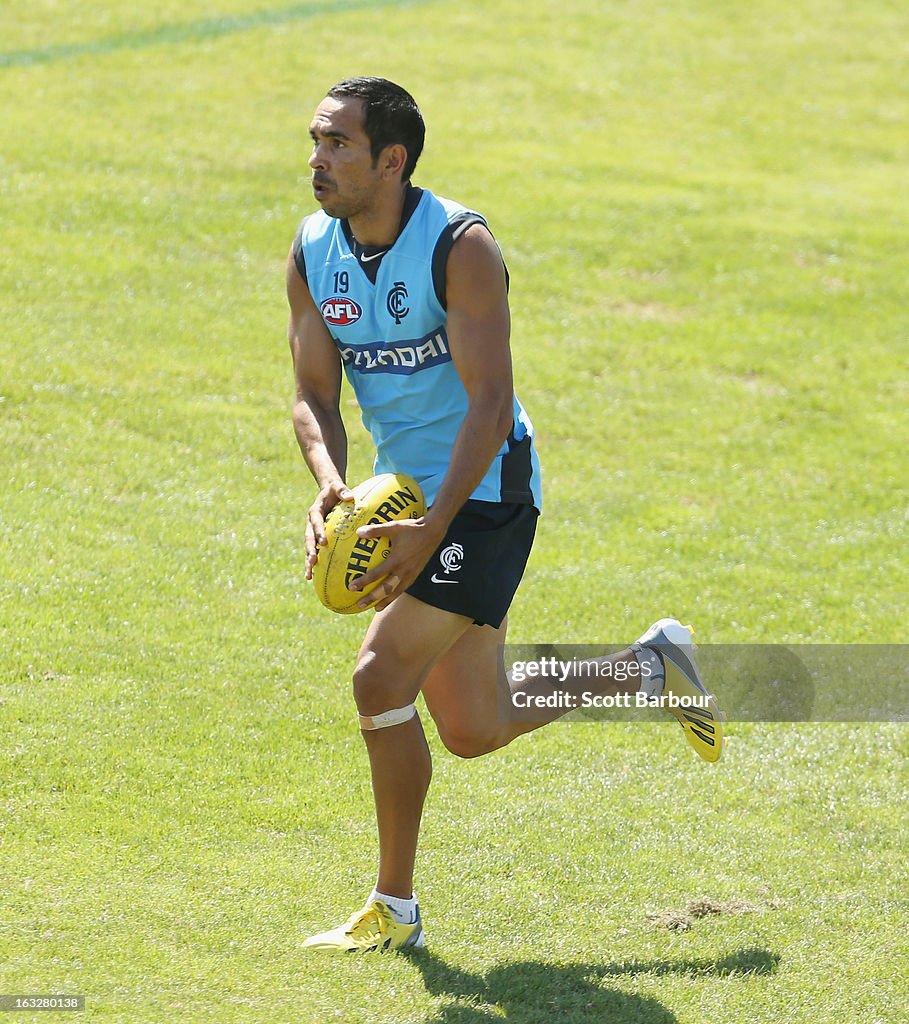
[{"xmin": 351, "ymin": 224, "xmax": 513, "ymax": 609}]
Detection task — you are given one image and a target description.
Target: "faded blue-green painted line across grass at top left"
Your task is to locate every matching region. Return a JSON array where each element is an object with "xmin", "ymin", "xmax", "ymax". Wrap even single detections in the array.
[{"xmin": 0, "ymin": 0, "xmax": 421, "ymax": 68}]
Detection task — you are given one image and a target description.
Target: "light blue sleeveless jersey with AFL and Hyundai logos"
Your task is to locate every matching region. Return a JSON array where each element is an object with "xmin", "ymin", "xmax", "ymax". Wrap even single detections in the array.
[{"xmin": 295, "ymin": 189, "xmax": 542, "ymax": 508}]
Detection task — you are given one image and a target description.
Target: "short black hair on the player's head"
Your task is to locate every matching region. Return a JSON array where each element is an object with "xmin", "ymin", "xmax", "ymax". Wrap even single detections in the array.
[{"xmin": 328, "ymin": 78, "xmax": 426, "ymax": 181}]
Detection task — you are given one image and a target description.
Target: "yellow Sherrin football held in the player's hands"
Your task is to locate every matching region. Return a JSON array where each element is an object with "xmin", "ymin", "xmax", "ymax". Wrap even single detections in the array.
[{"xmin": 312, "ymin": 473, "xmax": 426, "ymax": 614}]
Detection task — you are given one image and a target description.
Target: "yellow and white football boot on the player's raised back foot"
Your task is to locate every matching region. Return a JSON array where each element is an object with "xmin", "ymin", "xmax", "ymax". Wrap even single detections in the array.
[{"xmin": 632, "ymin": 618, "xmax": 724, "ymax": 762}]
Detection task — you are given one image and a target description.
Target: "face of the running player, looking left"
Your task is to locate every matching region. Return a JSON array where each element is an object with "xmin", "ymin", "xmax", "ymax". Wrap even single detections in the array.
[{"xmin": 309, "ymin": 97, "xmax": 381, "ymax": 218}]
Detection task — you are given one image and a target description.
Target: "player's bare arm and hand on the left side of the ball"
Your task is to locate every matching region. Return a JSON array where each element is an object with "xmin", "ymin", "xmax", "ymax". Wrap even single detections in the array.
[{"xmin": 286, "ymin": 241, "xmax": 353, "ymax": 579}]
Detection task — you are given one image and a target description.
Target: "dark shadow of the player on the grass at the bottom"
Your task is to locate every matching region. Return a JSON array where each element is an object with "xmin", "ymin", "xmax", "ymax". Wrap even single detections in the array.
[{"xmin": 407, "ymin": 948, "xmax": 780, "ymax": 1024}]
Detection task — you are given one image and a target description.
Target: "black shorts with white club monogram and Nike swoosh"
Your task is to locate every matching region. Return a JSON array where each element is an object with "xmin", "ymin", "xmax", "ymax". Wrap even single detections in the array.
[{"xmin": 407, "ymin": 499, "xmax": 539, "ymax": 629}]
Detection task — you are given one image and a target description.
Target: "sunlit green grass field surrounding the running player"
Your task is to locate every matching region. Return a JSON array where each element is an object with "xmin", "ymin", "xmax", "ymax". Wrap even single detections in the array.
[{"xmin": 0, "ymin": 0, "xmax": 909, "ymax": 1024}]
